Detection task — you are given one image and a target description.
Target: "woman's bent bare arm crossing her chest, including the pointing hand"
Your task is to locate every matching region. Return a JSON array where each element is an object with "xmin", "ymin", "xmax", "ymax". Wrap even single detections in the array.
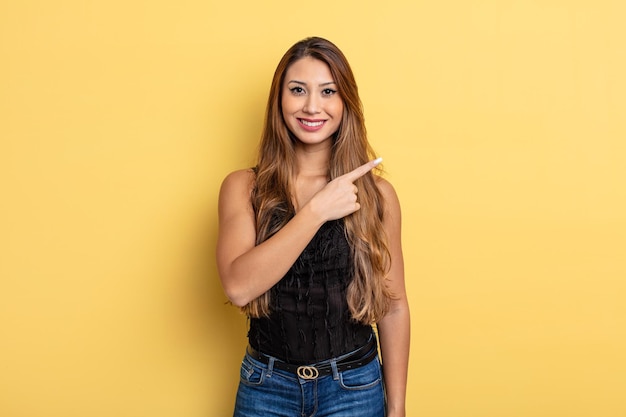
[{"xmin": 217, "ymin": 160, "xmax": 380, "ymax": 307}]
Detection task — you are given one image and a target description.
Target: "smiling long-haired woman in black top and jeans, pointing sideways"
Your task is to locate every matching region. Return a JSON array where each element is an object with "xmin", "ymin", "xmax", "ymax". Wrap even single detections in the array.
[{"xmin": 217, "ymin": 38, "xmax": 409, "ymax": 417}]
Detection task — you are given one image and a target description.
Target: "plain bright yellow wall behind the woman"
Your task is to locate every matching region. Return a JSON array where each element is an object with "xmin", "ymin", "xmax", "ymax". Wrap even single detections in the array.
[{"xmin": 0, "ymin": 0, "xmax": 626, "ymax": 417}]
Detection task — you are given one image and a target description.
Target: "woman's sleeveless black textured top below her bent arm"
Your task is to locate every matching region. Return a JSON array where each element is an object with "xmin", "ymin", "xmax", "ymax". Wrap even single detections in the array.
[{"xmin": 248, "ymin": 219, "xmax": 372, "ymax": 364}]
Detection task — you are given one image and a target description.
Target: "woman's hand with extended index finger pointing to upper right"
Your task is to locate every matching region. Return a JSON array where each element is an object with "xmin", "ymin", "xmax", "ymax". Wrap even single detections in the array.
[{"xmin": 308, "ymin": 158, "xmax": 383, "ymax": 221}]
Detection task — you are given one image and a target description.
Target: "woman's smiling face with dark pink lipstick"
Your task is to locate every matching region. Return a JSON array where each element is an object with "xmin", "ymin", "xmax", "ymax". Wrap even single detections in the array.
[{"xmin": 281, "ymin": 57, "xmax": 343, "ymax": 145}]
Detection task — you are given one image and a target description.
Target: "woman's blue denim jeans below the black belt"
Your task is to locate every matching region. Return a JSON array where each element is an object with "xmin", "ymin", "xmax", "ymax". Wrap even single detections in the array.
[{"xmin": 234, "ymin": 346, "xmax": 385, "ymax": 417}]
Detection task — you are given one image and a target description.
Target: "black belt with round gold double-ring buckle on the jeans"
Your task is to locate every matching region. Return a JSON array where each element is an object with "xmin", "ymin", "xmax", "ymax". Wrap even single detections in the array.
[{"xmin": 247, "ymin": 338, "xmax": 378, "ymax": 379}]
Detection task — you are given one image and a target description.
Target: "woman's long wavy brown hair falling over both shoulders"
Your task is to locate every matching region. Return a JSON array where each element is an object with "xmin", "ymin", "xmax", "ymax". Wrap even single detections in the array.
[{"xmin": 243, "ymin": 37, "xmax": 391, "ymax": 324}]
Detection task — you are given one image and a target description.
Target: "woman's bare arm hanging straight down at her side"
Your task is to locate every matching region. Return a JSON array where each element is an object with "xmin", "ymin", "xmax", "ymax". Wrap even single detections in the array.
[{"xmin": 377, "ymin": 179, "xmax": 410, "ymax": 417}]
